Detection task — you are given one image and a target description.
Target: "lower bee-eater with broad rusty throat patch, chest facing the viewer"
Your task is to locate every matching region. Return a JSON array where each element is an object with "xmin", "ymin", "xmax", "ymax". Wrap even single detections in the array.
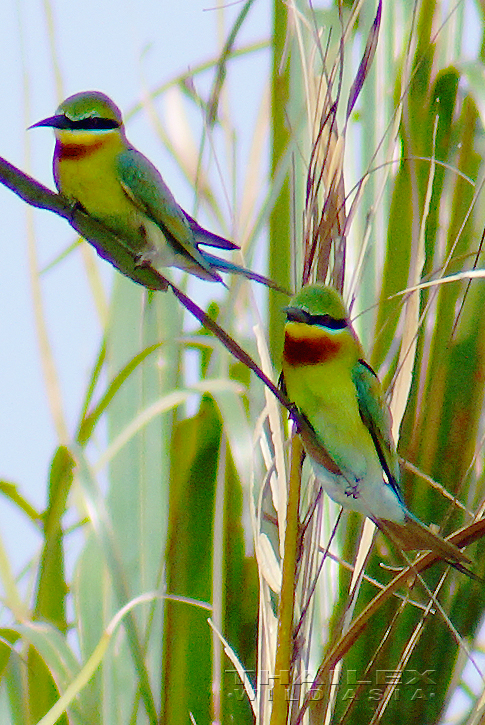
[{"xmin": 282, "ymin": 284, "xmax": 470, "ymax": 573}]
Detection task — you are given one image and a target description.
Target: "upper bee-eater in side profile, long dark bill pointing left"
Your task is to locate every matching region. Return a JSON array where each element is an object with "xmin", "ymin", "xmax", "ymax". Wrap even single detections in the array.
[{"xmin": 30, "ymin": 91, "xmax": 279, "ymax": 289}]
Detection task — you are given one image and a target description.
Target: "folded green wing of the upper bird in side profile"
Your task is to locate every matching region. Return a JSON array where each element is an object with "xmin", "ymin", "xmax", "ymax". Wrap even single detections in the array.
[{"xmin": 117, "ymin": 149, "xmax": 214, "ymax": 276}]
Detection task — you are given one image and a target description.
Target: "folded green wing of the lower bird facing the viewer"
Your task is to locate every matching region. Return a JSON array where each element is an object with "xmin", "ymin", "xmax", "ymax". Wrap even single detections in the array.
[{"xmin": 352, "ymin": 360, "xmax": 404, "ymax": 503}]
